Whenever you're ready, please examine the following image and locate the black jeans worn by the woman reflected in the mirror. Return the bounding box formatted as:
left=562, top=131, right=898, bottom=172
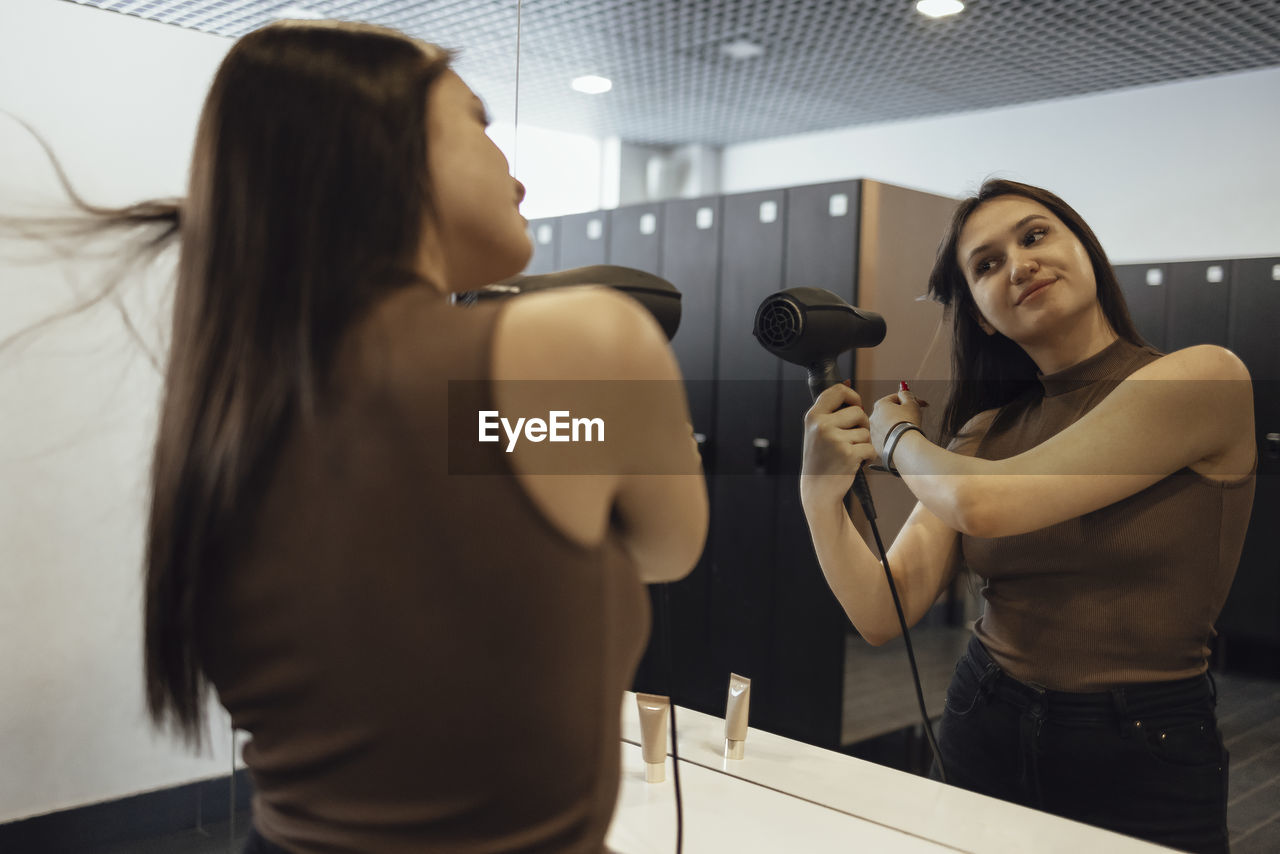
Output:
left=931, top=638, right=1228, bottom=854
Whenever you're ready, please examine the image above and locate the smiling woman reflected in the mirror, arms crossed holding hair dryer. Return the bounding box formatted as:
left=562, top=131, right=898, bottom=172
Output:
left=801, top=181, right=1256, bottom=851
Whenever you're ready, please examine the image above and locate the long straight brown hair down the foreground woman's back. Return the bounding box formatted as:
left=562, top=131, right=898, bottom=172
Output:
left=136, top=22, right=449, bottom=743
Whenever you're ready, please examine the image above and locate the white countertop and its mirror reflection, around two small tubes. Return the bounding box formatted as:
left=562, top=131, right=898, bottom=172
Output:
left=609, top=696, right=1171, bottom=854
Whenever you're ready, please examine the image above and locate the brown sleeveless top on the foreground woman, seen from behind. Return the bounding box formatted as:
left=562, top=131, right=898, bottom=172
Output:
left=206, top=288, right=649, bottom=854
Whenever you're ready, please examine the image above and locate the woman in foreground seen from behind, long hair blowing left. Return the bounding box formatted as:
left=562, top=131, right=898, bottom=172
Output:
left=42, top=15, right=707, bottom=854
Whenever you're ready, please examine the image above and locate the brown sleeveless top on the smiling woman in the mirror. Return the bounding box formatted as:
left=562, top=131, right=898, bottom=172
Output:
left=952, top=339, right=1254, bottom=691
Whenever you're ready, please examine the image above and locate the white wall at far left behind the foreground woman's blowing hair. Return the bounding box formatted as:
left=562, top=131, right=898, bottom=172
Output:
left=0, top=0, right=240, bottom=821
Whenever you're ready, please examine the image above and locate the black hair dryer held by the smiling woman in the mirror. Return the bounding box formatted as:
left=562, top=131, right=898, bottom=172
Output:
left=751, top=288, right=886, bottom=519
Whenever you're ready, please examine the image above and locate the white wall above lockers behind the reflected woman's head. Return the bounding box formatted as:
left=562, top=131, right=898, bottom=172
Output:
left=721, top=68, right=1280, bottom=262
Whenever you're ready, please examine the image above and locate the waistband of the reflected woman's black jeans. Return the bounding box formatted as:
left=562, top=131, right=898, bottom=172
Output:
left=968, top=638, right=1217, bottom=718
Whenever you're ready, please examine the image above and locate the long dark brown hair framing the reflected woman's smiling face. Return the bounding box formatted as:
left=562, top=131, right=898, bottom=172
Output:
left=929, top=179, right=1147, bottom=444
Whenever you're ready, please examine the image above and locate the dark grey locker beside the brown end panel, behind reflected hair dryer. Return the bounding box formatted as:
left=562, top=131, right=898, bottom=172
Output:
left=772, top=181, right=861, bottom=749
